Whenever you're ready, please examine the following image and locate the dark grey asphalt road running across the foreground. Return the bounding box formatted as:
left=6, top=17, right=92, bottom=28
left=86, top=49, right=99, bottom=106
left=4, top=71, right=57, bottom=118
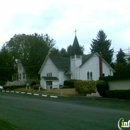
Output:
left=0, top=92, right=130, bottom=130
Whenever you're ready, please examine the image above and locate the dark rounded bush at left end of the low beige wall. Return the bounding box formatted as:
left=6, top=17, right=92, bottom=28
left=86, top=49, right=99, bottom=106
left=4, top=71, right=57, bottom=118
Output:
left=96, top=80, right=109, bottom=97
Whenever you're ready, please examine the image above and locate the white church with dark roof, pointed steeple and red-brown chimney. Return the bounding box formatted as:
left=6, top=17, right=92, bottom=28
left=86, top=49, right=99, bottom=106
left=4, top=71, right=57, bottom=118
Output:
left=39, top=36, right=114, bottom=89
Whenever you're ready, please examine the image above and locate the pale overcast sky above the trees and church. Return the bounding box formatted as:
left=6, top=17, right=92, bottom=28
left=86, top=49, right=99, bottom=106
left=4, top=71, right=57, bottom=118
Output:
left=0, top=0, right=130, bottom=57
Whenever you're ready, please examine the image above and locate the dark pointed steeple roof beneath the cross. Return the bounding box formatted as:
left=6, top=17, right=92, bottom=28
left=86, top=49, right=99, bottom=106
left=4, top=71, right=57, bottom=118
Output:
left=71, top=36, right=82, bottom=56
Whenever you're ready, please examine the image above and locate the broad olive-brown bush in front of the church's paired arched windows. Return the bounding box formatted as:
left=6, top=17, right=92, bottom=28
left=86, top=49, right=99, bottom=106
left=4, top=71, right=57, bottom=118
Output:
left=74, top=80, right=96, bottom=96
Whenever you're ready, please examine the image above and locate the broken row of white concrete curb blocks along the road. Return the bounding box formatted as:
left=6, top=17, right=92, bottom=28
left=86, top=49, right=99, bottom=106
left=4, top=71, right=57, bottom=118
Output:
left=1, top=90, right=58, bottom=98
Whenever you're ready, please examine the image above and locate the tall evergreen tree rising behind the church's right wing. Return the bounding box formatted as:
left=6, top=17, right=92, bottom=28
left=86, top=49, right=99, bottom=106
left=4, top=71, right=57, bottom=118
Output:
left=90, top=30, right=114, bottom=63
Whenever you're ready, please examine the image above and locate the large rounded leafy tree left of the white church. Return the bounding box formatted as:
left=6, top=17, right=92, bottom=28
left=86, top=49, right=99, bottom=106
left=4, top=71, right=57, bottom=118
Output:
left=6, top=33, right=55, bottom=78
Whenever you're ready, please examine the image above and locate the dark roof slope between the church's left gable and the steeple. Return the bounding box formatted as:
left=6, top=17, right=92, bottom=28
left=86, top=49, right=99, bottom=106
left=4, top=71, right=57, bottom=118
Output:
left=49, top=56, right=70, bottom=70
